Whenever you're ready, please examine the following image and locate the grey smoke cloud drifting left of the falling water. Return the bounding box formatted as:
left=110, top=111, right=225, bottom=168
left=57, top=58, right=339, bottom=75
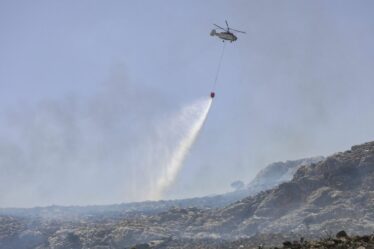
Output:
left=0, top=71, right=175, bottom=206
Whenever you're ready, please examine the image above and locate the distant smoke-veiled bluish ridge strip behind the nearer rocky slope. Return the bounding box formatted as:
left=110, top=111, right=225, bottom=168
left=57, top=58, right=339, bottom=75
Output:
left=0, top=157, right=323, bottom=220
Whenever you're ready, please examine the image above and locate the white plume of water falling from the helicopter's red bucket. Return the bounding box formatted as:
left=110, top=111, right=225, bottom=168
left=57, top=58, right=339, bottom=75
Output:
left=151, top=98, right=212, bottom=199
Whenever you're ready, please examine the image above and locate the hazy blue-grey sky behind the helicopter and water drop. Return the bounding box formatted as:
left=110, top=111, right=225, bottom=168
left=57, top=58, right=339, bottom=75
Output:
left=0, top=0, right=374, bottom=207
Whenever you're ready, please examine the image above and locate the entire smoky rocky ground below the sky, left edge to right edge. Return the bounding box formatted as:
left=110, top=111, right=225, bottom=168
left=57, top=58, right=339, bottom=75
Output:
left=0, top=142, right=374, bottom=249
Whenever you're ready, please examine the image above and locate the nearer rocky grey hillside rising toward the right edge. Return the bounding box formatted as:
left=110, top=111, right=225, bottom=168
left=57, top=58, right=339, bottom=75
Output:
left=115, top=142, right=374, bottom=246
